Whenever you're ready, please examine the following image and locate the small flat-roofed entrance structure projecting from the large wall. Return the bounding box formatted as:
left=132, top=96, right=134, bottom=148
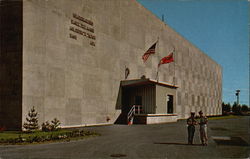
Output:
left=121, top=78, right=178, bottom=124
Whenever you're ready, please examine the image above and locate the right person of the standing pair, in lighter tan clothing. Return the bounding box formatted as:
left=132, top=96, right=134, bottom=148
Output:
left=199, top=111, right=208, bottom=146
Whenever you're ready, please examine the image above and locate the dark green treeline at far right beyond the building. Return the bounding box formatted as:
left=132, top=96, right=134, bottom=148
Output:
left=222, top=102, right=250, bottom=115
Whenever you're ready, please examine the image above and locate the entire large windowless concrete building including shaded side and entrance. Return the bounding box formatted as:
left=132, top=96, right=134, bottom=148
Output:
left=0, top=0, right=222, bottom=129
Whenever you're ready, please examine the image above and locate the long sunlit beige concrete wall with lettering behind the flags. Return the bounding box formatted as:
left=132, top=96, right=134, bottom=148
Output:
left=22, top=0, right=221, bottom=126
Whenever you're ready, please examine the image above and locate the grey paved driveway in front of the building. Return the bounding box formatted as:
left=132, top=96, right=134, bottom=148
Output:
left=0, top=117, right=250, bottom=159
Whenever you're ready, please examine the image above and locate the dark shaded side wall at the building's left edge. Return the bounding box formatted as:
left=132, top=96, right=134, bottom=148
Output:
left=0, top=0, right=22, bottom=130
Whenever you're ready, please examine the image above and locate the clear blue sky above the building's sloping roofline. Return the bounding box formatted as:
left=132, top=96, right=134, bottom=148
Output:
left=137, top=0, right=250, bottom=105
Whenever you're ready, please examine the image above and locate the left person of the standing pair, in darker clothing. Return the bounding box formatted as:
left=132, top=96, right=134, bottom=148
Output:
left=187, top=112, right=197, bottom=145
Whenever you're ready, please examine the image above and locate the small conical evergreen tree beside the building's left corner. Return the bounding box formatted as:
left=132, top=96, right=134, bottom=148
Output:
left=23, top=106, right=39, bottom=132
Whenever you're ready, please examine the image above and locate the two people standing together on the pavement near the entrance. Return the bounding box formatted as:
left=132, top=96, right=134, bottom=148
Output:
left=187, top=111, right=208, bottom=146
